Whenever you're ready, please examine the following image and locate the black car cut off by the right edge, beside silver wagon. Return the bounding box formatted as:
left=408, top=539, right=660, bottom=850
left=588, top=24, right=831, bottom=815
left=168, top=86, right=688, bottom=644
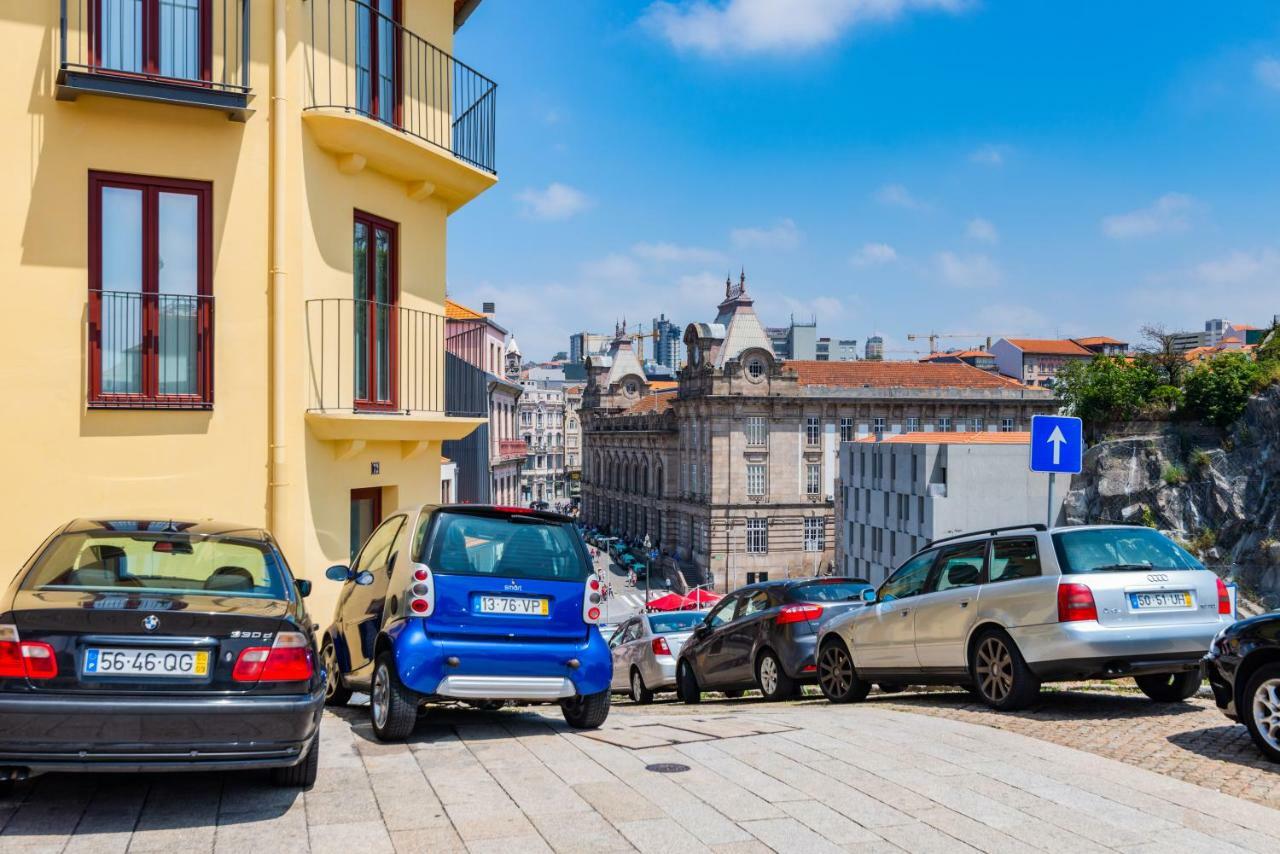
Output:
left=1204, top=612, right=1280, bottom=762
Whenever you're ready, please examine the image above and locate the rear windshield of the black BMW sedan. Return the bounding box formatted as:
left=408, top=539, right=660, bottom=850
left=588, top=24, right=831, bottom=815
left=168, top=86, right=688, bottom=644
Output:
left=22, top=531, right=287, bottom=599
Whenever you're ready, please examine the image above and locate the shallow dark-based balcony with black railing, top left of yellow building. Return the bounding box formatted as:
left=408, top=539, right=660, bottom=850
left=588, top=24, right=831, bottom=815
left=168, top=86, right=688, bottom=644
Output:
left=56, top=0, right=252, bottom=122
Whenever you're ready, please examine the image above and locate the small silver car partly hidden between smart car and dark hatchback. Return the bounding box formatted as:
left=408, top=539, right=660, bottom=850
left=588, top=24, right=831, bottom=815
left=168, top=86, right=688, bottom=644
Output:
left=609, top=611, right=707, bottom=703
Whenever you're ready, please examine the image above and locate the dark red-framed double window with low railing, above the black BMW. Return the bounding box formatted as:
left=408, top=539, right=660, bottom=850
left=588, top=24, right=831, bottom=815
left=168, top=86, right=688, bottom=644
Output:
left=88, top=172, right=214, bottom=408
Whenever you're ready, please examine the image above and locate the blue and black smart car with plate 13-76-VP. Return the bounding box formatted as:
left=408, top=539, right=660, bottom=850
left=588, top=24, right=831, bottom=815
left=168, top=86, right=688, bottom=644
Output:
left=321, top=504, right=613, bottom=740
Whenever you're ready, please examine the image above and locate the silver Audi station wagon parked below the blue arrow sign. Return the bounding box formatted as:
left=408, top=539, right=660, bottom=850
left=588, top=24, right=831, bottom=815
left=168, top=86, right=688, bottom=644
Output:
left=818, top=525, right=1233, bottom=709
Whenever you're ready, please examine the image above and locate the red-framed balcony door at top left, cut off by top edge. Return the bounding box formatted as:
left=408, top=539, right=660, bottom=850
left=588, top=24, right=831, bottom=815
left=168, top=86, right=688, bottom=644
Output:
left=88, top=0, right=212, bottom=81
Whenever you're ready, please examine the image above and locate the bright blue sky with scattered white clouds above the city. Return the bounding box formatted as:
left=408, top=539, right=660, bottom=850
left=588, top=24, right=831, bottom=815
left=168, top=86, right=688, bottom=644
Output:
left=448, top=0, right=1280, bottom=359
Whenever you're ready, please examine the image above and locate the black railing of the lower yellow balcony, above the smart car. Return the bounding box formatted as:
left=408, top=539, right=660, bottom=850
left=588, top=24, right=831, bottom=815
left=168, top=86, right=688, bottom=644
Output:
left=306, top=297, right=444, bottom=415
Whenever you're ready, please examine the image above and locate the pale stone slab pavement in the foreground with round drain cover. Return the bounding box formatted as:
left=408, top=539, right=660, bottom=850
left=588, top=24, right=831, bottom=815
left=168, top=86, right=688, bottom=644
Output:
left=0, top=698, right=1280, bottom=854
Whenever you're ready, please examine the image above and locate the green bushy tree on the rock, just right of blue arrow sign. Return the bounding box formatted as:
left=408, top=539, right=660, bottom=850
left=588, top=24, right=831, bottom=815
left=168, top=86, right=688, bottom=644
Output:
left=1053, top=356, right=1161, bottom=429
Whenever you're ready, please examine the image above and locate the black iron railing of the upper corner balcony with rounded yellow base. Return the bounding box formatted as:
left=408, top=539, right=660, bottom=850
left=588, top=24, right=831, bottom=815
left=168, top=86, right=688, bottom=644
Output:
left=305, top=0, right=498, bottom=173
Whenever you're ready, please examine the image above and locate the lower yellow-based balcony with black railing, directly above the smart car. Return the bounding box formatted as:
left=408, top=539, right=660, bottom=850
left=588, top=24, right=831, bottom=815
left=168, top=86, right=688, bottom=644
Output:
left=305, top=297, right=488, bottom=458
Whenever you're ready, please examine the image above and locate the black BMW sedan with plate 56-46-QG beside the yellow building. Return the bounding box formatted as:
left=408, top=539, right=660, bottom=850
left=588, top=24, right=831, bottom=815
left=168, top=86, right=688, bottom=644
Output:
left=0, top=520, right=324, bottom=786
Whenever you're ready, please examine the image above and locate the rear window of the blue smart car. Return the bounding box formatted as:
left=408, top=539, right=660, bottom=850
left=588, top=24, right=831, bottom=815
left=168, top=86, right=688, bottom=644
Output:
left=415, top=510, right=591, bottom=581
